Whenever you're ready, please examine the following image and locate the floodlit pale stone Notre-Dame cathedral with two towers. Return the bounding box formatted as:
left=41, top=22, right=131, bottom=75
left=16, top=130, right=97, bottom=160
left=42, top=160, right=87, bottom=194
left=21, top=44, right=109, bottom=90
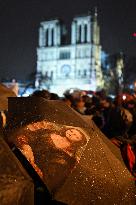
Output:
left=37, top=12, right=103, bottom=95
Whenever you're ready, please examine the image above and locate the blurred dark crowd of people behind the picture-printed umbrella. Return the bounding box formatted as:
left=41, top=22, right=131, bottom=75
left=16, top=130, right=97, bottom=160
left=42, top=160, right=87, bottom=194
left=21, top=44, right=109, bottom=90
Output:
left=31, top=90, right=136, bottom=176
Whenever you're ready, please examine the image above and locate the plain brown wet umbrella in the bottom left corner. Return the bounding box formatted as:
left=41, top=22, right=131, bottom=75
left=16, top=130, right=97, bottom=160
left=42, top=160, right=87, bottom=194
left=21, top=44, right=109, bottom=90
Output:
left=0, top=136, right=34, bottom=205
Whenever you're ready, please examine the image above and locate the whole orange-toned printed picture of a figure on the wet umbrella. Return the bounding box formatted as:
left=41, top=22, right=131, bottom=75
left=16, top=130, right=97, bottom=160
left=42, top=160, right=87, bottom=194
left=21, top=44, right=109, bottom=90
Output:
left=14, top=121, right=88, bottom=191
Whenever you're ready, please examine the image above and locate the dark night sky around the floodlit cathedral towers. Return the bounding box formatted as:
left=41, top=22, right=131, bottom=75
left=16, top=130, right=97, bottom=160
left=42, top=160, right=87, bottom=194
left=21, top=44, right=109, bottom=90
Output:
left=0, top=0, right=136, bottom=80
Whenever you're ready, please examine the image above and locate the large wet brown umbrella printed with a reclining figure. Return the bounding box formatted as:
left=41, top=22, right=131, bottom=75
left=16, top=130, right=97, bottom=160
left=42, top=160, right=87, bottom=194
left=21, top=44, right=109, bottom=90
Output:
left=8, top=97, right=136, bottom=205
